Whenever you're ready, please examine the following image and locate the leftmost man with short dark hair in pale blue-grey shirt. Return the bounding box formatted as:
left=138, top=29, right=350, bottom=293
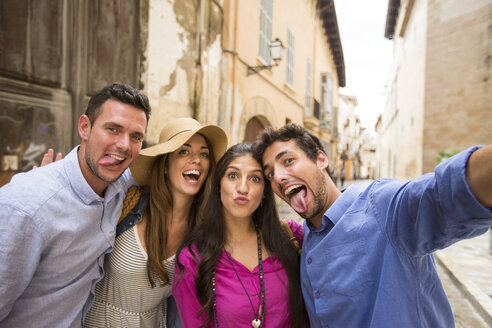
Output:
left=0, top=84, right=150, bottom=327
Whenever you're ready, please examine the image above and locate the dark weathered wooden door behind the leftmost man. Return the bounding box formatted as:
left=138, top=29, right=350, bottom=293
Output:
left=0, top=0, right=146, bottom=185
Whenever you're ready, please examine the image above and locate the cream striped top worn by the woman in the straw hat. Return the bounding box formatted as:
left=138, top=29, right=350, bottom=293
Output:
left=84, top=226, right=175, bottom=328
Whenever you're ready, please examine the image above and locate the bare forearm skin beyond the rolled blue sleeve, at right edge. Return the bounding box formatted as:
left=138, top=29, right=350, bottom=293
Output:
left=466, top=145, right=492, bottom=207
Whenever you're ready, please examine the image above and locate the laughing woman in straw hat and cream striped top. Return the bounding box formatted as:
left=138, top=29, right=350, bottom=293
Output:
left=84, top=118, right=227, bottom=327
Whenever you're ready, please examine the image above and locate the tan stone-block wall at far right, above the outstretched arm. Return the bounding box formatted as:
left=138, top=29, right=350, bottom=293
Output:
left=423, top=0, right=492, bottom=172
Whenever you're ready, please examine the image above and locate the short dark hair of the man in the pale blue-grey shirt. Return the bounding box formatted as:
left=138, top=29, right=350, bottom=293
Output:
left=85, top=83, right=151, bottom=125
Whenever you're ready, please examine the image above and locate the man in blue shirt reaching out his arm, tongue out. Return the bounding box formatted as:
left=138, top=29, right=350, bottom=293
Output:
left=255, top=124, right=492, bottom=328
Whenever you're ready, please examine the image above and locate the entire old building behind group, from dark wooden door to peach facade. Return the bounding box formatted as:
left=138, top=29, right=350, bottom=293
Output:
left=0, top=0, right=345, bottom=185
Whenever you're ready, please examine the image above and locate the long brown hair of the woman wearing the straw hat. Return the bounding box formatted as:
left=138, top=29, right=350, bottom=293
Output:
left=145, top=137, right=215, bottom=287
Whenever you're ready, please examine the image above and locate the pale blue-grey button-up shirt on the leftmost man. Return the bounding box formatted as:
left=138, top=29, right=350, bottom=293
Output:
left=0, top=147, right=134, bottom=327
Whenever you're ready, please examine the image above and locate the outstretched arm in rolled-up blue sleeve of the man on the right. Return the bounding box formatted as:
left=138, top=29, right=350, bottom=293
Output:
left=370, top=145, right=492, bottom=256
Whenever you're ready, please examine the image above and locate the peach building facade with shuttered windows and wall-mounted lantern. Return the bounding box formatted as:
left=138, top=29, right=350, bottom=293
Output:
left=219, top=0, right=345, bottom=159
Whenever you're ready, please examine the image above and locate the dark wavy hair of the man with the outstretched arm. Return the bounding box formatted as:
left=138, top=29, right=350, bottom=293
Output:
left=253, top=123, right=331, bottom=178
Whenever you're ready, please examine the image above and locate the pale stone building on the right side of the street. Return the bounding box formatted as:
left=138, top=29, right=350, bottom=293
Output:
left=378, top=0, right=492, bottom=179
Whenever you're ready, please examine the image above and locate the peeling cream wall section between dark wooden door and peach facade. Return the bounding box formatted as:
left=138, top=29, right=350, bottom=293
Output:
left=141, top=0, right=222, bottom=144
